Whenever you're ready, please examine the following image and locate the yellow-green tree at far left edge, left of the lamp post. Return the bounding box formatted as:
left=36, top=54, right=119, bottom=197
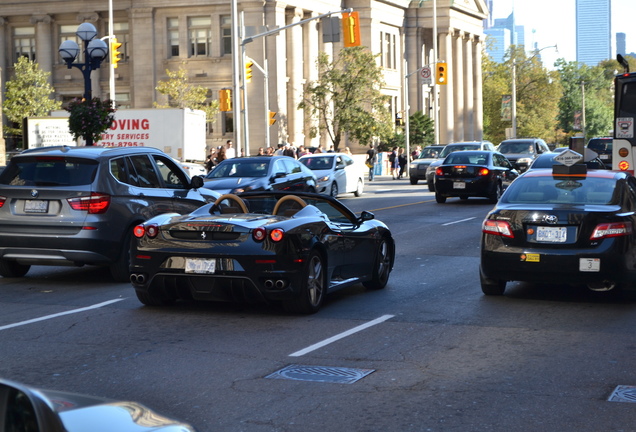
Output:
left=3, top=57, right=62, bottom=136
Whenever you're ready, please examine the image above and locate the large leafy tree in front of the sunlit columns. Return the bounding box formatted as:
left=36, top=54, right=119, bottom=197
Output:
left=298, top=47, right=393, bottom=151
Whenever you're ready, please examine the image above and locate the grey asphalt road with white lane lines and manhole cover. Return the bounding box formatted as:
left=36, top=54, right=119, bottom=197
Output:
left=0, top=177, right=636, bottom=432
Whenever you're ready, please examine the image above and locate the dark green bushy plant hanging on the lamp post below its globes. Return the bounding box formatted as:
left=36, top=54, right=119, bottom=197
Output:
left=66, top=98, right=115, bottom=143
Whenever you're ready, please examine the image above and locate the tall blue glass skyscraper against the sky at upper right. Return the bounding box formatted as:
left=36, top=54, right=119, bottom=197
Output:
left=576, top=0, right=612, bottom=66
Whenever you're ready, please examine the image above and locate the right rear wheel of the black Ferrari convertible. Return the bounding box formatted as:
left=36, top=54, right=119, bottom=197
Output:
left=283, top=250, right=327, bottom=314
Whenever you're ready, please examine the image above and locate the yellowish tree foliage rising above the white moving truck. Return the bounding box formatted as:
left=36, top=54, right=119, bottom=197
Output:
left=155, top=65, right=219, bottom=123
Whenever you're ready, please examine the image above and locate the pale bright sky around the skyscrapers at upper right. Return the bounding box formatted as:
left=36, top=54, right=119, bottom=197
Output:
left=491, top=0, right=636, bottom=69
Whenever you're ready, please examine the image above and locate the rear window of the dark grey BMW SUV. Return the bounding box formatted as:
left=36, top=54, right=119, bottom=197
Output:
left=0, top=156, right=98, bottom=186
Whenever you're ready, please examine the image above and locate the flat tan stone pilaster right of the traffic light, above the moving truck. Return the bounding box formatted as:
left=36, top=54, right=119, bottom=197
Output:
left=128, top=8, right=154, bottom=107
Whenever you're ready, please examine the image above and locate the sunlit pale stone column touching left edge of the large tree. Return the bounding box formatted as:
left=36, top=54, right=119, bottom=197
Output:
left=287, top=8, right=305, bottom=145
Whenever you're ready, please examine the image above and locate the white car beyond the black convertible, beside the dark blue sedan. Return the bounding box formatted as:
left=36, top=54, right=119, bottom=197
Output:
left=298, top=153, right=364, bottom=197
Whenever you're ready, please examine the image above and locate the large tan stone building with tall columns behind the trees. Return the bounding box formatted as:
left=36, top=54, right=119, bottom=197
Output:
left=0, top=0, right=488, bottom=157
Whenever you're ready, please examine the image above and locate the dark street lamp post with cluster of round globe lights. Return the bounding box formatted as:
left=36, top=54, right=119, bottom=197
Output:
left=58, top=23, right=108, bottom=146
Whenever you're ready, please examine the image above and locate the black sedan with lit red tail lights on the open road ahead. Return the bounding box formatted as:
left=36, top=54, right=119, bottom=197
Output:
left=435, top=151, right=519, bottom=203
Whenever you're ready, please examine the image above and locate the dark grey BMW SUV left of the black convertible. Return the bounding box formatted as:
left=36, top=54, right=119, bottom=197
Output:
left=0, top=146, right=219, bottom=282
